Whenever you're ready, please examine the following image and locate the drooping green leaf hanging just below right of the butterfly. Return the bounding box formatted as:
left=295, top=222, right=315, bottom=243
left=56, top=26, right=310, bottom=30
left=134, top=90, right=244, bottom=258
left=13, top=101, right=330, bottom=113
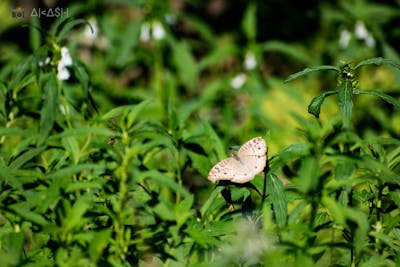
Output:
left=267, top=172, right=288, bottom=227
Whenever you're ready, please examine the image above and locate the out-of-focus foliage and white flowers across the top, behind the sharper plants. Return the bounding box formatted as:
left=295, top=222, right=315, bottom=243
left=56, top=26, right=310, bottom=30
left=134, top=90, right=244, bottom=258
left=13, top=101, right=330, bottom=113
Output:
left=0, top=0, right=400, bottom=153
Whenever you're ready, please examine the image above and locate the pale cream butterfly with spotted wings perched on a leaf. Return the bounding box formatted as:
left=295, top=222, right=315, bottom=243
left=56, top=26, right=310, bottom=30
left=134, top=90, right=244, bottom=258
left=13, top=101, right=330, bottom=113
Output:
left=208, top=136, right=267, bottom=184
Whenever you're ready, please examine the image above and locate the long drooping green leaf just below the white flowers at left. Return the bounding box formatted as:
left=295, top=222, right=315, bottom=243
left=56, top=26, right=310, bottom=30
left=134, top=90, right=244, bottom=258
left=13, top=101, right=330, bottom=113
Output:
left=38, top=75, right=58, bottom=144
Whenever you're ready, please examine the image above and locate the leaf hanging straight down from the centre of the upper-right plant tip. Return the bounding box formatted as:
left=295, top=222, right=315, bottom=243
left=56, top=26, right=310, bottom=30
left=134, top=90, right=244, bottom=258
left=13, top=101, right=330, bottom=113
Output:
left=338, top=79, right=353, bottom=129
